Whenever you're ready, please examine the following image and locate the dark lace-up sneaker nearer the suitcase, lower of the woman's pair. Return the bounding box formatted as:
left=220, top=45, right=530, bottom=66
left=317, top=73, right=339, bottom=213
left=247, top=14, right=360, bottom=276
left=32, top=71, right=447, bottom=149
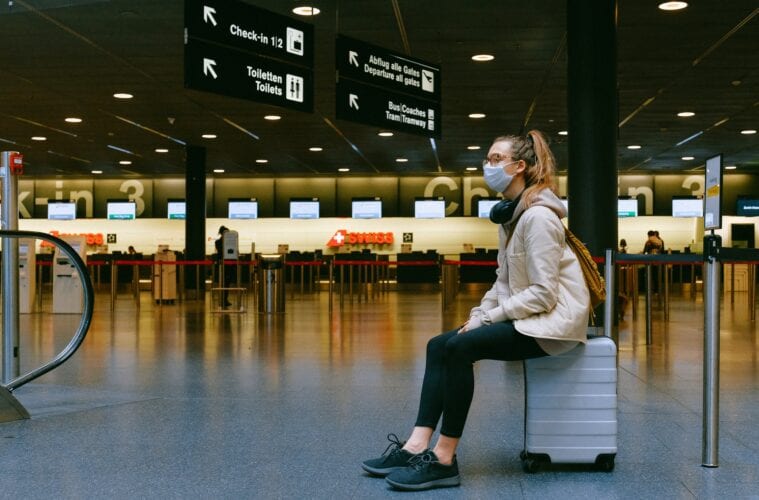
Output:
left=385, top=450, right=461, bottom=491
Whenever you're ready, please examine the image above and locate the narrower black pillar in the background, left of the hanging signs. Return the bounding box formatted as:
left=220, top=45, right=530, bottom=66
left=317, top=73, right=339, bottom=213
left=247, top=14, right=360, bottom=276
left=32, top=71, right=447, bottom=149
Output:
left=184, top=146, right=206, bottom=298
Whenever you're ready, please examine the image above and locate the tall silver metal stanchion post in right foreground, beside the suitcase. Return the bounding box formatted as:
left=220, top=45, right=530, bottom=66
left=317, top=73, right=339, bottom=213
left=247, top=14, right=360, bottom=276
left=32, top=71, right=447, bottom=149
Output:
left=701, top=234, right=722, bottom=467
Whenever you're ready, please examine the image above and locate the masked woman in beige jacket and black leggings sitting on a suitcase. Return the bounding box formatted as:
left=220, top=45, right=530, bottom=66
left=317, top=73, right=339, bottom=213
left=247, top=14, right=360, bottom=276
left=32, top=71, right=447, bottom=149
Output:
left=362, top=130, right=590, bottom=490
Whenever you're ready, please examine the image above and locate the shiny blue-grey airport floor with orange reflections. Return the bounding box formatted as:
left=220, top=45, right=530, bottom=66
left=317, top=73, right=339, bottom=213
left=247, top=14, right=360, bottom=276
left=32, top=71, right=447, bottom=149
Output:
left=0, top=284, right=759, bottom=499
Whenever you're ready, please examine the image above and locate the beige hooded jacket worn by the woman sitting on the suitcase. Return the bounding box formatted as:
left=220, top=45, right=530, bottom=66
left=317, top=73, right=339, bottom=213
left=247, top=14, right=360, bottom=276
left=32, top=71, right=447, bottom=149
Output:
left=471, top=189, right=590, bottom=355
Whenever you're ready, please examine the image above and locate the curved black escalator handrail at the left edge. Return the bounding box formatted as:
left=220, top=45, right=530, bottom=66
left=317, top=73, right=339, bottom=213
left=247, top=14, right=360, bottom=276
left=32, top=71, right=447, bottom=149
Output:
left=0, top=230, right=95, bottom=392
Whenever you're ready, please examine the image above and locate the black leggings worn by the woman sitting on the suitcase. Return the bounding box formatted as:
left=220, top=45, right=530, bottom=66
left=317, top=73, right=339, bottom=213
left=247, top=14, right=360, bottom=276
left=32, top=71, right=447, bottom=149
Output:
left=416, top=321, right=547, bottom=438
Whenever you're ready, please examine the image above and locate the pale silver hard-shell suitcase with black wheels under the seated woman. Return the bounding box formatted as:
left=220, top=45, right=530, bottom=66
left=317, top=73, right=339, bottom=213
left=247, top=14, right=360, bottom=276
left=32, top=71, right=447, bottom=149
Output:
left=521, top=337, right=617, bottom=472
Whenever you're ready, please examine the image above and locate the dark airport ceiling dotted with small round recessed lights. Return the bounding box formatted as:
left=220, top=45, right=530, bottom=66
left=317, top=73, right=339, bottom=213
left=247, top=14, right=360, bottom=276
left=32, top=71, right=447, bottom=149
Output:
left=0, top=0, right=759, bottom=177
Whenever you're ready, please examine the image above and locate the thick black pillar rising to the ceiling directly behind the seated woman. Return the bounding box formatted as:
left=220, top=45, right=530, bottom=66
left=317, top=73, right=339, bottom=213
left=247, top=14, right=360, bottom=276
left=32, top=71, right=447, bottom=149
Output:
left=567, top=0, right=618, bottom=304
